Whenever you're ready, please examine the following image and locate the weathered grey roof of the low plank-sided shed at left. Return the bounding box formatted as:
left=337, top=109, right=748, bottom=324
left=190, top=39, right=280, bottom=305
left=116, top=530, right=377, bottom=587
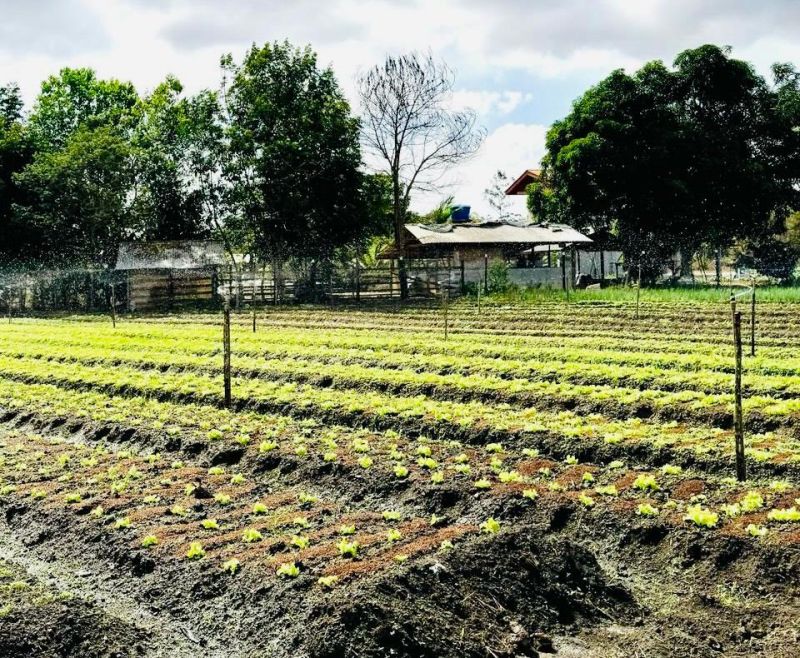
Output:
left=116, top=240, right=225, bottom=270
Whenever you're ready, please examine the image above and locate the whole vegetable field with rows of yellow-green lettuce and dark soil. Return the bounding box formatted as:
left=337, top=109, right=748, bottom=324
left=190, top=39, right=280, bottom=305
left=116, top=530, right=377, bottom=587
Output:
left=0, top=300, right=800, bottom=658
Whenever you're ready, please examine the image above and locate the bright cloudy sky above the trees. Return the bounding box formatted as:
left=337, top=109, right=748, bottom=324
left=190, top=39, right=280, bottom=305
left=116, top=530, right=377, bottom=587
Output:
left=0, top=0, right=800, bottom=214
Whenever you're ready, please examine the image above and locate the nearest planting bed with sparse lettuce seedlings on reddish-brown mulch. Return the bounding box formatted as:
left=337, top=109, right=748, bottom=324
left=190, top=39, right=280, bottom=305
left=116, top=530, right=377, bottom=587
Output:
left=0, top=420, right=800, bottom=587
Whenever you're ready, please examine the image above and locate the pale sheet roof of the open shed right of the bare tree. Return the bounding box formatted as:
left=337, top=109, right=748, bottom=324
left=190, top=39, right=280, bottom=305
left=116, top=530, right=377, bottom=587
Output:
left=406, top=223, right=591, bottom=245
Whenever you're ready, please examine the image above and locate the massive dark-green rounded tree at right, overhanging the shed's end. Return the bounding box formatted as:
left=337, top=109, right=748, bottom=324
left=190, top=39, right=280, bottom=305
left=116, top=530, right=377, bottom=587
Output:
left=529, top=45, right=796, bottom=278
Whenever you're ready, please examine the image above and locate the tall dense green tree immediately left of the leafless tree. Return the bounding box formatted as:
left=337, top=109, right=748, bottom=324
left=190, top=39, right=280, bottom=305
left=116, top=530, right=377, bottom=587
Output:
left=222, top=42, right=365, bottom=258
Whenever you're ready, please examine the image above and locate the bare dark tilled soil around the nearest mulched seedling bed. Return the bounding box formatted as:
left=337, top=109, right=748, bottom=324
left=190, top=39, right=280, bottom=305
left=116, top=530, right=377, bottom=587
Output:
left=0, top=408, right=800, bottom=658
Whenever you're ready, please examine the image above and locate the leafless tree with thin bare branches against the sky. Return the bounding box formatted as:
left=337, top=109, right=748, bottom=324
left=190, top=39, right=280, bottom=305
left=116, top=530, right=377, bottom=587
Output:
left=358, top=53, right=484, bottom=299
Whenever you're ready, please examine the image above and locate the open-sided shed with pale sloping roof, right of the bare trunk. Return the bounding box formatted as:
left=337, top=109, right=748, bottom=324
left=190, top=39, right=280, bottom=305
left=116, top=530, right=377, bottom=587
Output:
left=381, top=221, right=591, bottom=287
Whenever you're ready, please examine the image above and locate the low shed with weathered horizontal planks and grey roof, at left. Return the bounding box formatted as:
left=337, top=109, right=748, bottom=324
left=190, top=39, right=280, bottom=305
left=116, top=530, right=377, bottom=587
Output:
left=115, top=240, right=225, bottom=311
